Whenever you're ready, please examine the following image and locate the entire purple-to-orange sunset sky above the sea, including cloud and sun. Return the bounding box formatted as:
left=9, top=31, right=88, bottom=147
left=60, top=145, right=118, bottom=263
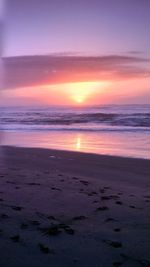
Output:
left=0, top=0, right=150, bottom=105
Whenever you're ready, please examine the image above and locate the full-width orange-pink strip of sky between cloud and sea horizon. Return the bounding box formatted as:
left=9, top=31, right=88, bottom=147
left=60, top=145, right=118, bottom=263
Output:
left=0, top=78, right=150, bottom=106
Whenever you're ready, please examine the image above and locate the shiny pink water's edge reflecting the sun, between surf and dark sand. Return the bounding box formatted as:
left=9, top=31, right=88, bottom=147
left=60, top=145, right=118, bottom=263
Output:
left=0, top=131, right=150, bottom=159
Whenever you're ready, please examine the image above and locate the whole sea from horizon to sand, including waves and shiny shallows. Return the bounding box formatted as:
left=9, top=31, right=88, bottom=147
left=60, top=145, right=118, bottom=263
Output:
left=0, top=105, right=150, bottom=159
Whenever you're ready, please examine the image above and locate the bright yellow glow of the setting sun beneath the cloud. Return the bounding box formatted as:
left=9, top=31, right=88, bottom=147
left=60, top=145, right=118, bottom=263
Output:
left=36, top=81, right=110, bottom=106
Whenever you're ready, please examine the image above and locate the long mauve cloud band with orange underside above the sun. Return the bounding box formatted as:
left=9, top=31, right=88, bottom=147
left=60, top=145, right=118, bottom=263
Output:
left=3, top=54, right=150, bottom=89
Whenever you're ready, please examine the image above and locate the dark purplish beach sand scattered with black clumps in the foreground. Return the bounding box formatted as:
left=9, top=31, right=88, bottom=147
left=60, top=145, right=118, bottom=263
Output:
left=0, top=147, right=150, bottom=267
